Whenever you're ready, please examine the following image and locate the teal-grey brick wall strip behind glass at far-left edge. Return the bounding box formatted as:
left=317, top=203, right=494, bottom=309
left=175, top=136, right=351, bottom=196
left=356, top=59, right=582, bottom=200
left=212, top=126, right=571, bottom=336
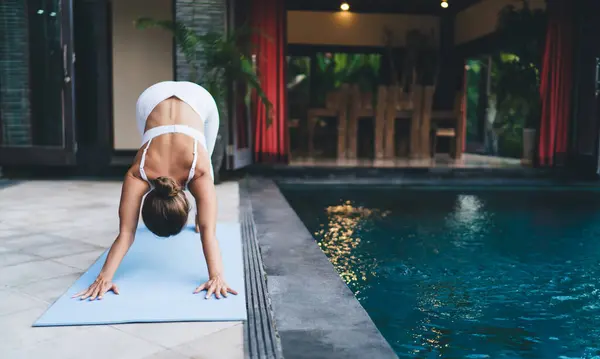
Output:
left=0, top=0, right=31, bottom=146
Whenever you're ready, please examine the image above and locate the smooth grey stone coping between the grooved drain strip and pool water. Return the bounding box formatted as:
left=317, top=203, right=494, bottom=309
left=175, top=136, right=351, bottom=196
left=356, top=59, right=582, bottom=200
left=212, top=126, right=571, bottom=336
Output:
left=240, top=177, right=397, bottom=359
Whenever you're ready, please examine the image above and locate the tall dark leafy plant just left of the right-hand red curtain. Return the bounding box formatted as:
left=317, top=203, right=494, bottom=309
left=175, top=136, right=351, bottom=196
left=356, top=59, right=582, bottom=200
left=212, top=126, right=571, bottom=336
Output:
left=495, top=0, right=546, bottom=163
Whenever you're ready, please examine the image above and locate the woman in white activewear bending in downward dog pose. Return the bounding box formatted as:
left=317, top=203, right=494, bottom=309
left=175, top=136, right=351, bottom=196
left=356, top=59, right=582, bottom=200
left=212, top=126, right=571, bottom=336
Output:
left=73, top=81, right=237, bottom=300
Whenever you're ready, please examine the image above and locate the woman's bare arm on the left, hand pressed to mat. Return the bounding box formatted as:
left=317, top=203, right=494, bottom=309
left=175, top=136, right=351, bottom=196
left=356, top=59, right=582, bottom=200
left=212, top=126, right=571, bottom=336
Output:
left=74, top=171, right=148, bottom=300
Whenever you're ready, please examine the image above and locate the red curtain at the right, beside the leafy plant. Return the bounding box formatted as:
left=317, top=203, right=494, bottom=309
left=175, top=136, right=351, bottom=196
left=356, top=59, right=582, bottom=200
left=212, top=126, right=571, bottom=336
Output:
left=538, top=0, right=574, bottom=166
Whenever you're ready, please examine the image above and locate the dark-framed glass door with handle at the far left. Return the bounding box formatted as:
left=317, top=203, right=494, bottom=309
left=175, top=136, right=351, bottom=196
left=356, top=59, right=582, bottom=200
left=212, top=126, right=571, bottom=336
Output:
left=0, top=0, right=76, bottom=165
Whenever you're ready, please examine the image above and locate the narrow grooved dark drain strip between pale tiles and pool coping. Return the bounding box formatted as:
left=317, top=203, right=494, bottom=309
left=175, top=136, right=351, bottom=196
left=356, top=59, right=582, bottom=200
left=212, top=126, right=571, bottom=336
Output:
left=239, top=181, right=283, bottom=359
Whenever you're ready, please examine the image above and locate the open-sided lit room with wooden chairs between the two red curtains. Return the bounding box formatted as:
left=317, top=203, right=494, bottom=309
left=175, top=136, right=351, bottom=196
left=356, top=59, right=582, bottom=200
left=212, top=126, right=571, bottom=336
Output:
left=286, top=0, right=545, bottom=168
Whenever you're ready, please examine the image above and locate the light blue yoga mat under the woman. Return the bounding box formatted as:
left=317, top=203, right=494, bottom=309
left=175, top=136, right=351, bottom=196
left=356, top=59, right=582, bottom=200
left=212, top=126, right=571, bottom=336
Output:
left=33, top=223, right=246, bottom=327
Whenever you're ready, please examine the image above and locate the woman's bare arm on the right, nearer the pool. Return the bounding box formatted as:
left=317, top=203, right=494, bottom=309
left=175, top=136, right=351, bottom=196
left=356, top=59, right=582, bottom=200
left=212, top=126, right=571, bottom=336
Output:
left=189, top=173, right=237, bottom=299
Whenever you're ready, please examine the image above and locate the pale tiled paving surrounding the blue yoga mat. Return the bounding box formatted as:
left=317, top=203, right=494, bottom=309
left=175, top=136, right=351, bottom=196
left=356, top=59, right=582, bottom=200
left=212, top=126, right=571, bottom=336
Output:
left=0, top=181, right=244, bottom=359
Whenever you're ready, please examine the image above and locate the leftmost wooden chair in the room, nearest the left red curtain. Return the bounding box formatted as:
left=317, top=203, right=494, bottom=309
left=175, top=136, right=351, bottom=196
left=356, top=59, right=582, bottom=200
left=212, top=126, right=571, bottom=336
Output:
left=307, top=85, right=349, bottom=159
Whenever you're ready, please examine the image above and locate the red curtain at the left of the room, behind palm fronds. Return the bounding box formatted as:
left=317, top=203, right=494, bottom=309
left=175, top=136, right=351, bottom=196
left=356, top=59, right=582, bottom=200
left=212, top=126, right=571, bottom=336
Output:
left=251, top=0, right=289, bottom=163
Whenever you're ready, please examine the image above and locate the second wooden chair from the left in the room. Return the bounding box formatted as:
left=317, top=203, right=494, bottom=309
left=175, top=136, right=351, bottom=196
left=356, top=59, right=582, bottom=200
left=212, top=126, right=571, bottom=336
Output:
left=347, top=85, right=387, bottom=159
